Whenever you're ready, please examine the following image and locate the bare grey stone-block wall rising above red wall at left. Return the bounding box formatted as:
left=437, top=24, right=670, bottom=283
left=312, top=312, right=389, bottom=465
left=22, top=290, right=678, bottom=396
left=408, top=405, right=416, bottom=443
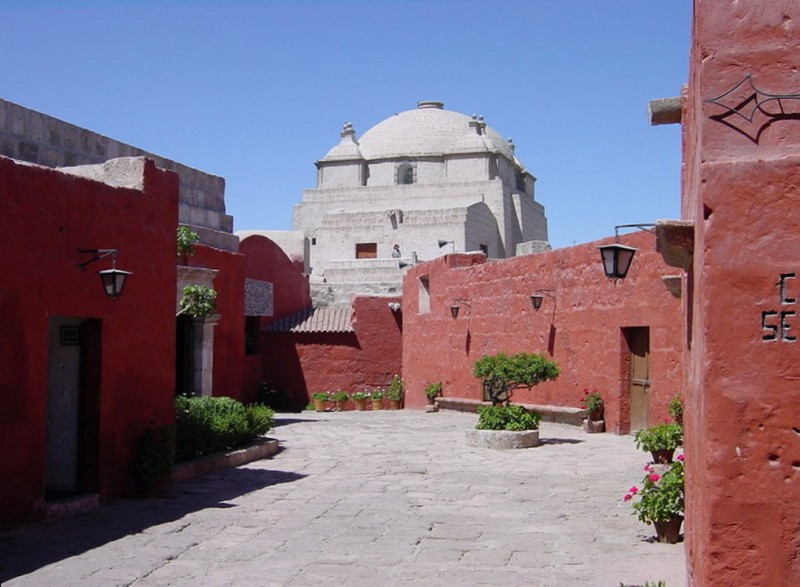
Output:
left=0, top=99, right=238, bottom=251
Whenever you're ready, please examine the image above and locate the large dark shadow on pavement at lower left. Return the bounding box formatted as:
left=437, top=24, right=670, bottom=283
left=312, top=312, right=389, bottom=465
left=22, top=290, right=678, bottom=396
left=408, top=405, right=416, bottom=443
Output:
left=0, top=468, right=305, bottom=584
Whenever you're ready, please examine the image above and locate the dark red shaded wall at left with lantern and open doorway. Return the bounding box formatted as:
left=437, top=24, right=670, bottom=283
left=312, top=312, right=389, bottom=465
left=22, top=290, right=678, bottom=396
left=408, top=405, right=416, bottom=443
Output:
left=0, top=157, right=178, bottom=527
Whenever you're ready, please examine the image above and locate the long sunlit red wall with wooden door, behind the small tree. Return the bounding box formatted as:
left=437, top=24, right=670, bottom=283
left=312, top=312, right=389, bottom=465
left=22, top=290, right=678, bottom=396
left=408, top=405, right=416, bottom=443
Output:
left=403, top=232, right=683, bottom=432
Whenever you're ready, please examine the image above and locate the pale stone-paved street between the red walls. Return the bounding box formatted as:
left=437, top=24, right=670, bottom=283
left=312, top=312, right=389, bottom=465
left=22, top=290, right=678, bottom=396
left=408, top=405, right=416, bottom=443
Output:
left=0, top=410, right=684, bottom=587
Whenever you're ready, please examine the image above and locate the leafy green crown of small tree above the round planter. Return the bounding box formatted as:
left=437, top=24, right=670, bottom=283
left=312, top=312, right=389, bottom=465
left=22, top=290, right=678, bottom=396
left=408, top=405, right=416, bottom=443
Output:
left=472, top=353, right=560, bottom=406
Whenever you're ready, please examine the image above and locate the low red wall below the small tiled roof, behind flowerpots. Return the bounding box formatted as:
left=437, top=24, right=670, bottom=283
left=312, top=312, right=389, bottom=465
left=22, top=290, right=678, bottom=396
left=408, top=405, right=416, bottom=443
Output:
left=263, top=296, right=403, bottom=408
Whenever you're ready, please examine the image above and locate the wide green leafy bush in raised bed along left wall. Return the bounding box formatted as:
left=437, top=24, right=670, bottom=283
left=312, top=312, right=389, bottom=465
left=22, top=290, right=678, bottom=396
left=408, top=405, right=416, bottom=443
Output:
left=175, top=396, right=275, bottom=461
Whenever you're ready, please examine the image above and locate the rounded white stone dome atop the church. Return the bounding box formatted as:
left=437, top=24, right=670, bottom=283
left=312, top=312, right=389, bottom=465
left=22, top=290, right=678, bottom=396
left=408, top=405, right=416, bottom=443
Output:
left=358, top=102, right=514, bottom=160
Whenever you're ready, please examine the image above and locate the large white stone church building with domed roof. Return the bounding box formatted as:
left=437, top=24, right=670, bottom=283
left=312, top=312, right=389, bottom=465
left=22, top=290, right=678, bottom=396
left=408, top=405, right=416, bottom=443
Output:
left=294, top=102, right=547, bottom=305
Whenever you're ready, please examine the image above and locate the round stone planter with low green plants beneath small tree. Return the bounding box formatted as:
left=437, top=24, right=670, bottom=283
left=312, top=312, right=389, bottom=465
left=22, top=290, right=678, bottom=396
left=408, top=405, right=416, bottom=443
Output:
left=467, top=405, right=542, bottom=449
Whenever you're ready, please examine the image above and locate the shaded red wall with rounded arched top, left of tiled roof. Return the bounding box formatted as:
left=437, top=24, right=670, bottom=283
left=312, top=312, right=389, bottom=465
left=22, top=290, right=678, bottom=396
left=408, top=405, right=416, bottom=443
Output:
left=239, top=235, right=311, bottom=401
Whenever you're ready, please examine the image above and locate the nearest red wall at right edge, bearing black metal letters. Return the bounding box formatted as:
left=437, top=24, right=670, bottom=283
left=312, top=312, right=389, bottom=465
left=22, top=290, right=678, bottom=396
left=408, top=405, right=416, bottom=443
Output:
left=682, top=0, right=800, bottom=585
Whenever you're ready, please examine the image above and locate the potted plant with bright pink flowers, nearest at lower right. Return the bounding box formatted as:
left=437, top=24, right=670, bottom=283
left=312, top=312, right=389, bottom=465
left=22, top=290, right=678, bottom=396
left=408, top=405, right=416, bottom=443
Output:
left=622, top=455, right=684, bottom=544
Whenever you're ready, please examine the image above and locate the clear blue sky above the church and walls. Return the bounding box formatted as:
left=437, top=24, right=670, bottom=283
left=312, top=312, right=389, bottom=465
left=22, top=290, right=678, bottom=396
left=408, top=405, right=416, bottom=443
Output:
left=0, top=0, right=691, bottom=247
